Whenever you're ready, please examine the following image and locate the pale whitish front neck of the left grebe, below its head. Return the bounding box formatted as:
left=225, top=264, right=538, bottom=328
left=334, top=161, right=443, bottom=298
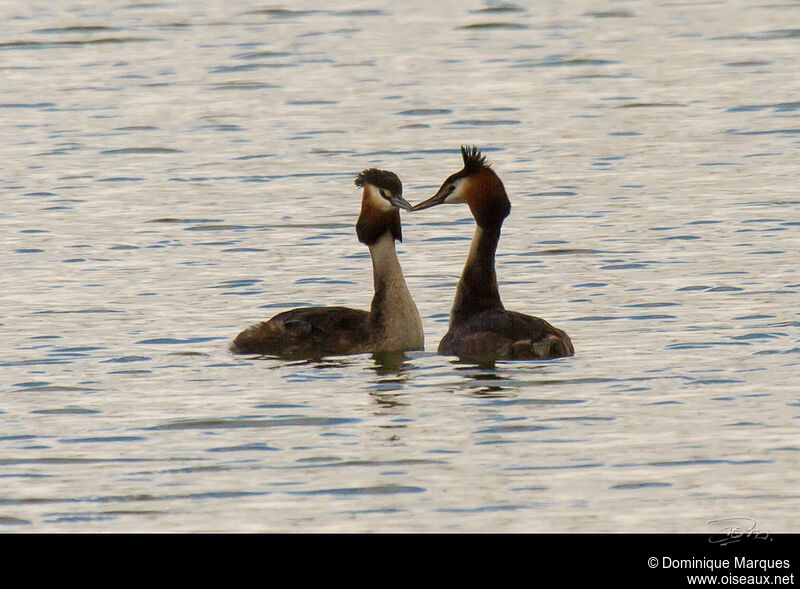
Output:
left=369, top=233, right=425, bottom=351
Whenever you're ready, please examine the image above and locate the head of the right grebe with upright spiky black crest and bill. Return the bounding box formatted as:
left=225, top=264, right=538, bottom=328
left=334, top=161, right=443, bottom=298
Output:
left=411, top=146, right=511, bottom=227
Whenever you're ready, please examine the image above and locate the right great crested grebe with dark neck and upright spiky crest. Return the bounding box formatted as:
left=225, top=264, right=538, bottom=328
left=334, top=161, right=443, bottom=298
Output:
left=411, top=147, right=575, bottom=360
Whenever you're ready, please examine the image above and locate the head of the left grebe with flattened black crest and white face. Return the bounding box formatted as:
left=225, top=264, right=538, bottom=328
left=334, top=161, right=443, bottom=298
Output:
left=355, top=168, right=411, bottom=245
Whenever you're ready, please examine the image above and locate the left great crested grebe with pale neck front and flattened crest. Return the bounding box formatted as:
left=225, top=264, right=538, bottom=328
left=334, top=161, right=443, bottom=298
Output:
left=230, top=168, right=425, bottom=358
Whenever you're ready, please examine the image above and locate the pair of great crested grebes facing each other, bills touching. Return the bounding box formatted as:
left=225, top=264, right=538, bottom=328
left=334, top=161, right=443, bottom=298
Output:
left=231, top=147, right=575, bottom=361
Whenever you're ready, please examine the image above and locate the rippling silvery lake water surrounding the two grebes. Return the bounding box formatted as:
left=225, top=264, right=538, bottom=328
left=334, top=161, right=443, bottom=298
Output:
left=0, top=0, right=800, bottom=532
